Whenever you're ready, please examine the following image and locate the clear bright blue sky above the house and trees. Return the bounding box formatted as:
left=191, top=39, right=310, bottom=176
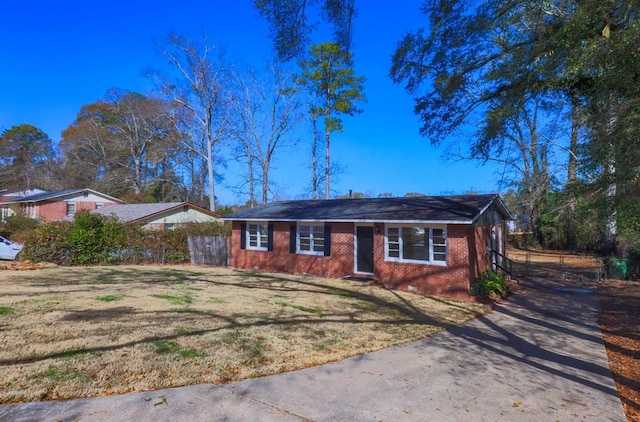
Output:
left=0, top=0, right=505, bottom=204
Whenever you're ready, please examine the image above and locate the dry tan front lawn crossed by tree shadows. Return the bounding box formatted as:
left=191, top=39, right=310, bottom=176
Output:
left=0, top=266, right=488, bottom=403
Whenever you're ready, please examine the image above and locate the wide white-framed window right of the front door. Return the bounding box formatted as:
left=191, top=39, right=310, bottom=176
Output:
left=384, top=225, right=447, bottom=265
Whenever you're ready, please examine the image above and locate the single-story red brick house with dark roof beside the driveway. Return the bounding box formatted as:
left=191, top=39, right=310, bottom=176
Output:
left=224, top=194, right=512, bottom=300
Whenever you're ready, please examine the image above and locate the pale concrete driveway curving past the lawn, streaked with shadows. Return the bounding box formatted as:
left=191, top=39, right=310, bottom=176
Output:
left=0, top=280, right=625, bottom=422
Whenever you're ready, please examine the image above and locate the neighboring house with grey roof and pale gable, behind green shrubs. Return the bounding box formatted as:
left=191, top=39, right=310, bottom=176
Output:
left=94, top=202, right=220, bottom=230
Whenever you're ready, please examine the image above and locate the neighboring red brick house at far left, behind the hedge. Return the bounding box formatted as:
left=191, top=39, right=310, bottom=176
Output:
left=0, top=189, right=123, bottom=221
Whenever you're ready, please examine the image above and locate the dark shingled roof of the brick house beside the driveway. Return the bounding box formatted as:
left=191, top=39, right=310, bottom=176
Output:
left=223, top=194, right=511, bottom=224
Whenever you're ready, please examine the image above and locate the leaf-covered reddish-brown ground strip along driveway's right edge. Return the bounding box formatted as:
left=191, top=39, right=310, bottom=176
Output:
left=597, top=280, right=640, bottom=422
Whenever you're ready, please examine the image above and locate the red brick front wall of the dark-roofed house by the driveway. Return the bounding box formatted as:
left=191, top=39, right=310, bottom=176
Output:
left=231, top=221, right=500, bottom=300
